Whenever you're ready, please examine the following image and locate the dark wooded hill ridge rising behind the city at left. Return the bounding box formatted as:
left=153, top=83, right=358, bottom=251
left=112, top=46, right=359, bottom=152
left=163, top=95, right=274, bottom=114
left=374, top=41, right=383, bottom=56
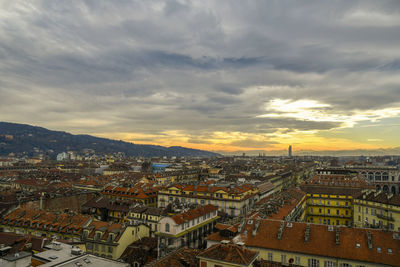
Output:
left=0, top=122, right=219, bottom=158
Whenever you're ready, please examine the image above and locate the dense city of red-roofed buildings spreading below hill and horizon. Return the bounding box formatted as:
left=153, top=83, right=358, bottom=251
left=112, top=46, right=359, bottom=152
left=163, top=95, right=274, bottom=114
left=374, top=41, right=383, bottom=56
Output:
left=0, top=148, right=400, bottom=267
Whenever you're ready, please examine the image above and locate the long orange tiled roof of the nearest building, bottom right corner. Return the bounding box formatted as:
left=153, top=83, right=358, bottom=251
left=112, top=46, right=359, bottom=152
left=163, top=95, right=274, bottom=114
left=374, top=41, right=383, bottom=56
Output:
left=207, top=219, right=400, bottom=266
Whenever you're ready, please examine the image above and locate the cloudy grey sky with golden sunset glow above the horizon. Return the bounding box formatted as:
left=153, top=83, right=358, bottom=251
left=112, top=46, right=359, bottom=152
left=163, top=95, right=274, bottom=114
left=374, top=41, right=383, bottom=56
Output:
left=0, top=0, right=400, bottom=153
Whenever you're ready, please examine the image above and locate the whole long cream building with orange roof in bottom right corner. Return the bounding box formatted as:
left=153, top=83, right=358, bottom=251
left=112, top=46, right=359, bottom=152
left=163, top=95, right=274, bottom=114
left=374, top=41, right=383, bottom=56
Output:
left=207, top=219, right=400, bottom=267
